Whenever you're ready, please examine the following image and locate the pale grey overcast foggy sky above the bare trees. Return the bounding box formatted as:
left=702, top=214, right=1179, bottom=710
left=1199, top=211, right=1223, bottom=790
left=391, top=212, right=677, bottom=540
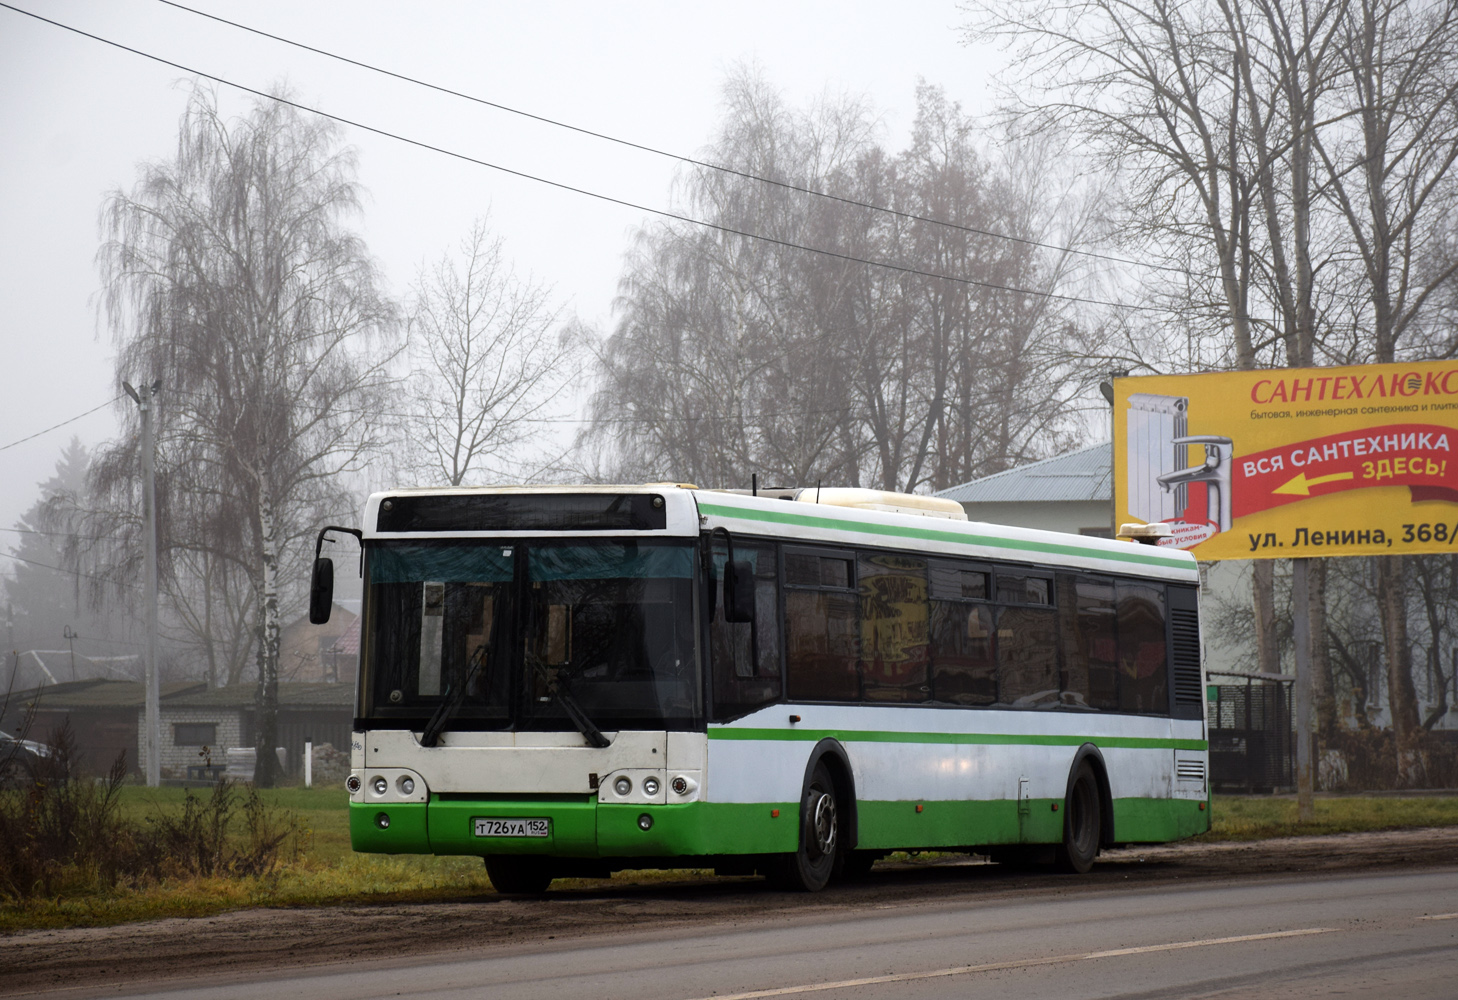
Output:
left=0, top=0, right=1000, bottom=571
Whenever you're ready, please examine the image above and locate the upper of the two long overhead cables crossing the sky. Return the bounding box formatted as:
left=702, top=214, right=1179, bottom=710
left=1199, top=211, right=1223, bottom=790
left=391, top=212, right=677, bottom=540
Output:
left=157, top=0, right=1198, bottom=277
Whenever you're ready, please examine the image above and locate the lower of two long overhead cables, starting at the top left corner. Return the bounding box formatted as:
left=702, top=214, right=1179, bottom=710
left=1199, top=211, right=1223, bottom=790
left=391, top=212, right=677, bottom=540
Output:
left=0, top=3, right=1162, bottom=312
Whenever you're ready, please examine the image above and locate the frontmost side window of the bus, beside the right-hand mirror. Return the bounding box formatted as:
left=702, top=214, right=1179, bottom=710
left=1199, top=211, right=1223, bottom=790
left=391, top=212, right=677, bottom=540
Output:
left=709, top=542, right=781, bottom=722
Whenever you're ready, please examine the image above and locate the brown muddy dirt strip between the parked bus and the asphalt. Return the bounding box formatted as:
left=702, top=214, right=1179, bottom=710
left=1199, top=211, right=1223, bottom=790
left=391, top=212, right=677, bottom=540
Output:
left=0, top=828, right=1458, bottom=996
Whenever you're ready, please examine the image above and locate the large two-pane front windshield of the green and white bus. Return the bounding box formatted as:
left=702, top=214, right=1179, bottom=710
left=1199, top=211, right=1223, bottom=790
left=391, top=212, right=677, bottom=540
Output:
left=363, top=539, right=703, bottom=730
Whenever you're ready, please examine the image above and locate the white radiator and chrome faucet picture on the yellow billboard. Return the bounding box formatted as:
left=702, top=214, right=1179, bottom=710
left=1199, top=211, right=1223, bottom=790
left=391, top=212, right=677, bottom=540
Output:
left=1124, top=392, right=1235, bottom=548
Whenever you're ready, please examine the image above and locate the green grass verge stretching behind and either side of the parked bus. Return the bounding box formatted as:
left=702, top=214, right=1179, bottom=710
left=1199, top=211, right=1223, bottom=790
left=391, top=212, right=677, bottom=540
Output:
left=8, top=786, right=1458, bottom=933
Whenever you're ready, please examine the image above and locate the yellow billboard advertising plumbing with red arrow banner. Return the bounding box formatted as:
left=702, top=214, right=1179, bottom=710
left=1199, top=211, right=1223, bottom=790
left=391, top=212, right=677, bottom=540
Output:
left=1114, top=362, right=1458, bottom=560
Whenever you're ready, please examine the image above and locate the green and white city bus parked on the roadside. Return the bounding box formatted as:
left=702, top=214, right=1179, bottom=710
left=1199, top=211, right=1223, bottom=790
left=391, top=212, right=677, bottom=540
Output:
left=311, top=484, right=1210, bottom=892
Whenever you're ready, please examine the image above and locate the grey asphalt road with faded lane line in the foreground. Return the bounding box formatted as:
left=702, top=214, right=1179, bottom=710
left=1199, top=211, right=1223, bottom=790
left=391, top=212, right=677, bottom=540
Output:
left=76, top=869, right=1458, bottom=1000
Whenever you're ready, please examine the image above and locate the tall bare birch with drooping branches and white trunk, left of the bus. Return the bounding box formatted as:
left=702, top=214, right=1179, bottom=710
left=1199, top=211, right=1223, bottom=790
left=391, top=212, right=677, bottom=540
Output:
left=93, top=87, right=394, bottom=787
